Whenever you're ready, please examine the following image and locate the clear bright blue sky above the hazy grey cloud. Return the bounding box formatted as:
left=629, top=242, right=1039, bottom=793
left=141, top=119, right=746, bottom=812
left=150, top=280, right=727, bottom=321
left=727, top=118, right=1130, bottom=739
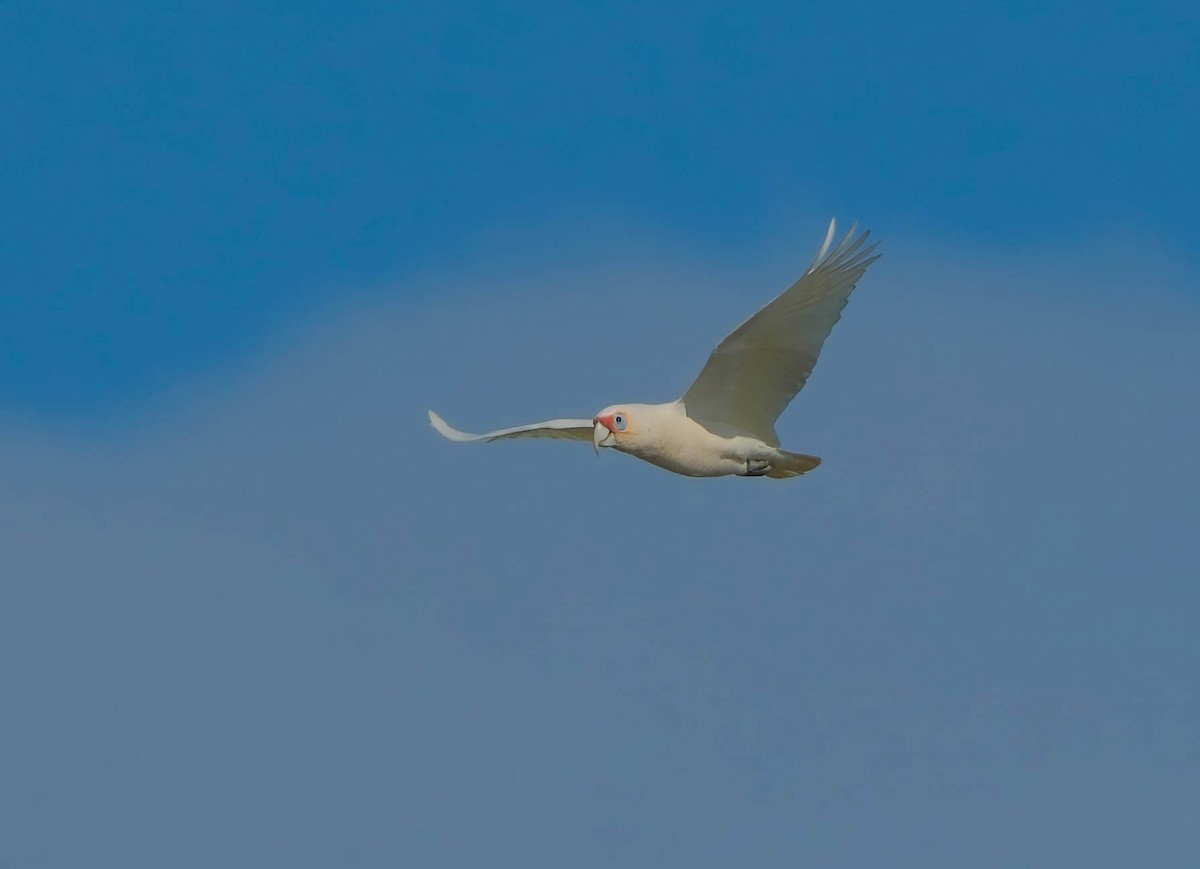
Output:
left=0, top=2, right=1200, bottom=419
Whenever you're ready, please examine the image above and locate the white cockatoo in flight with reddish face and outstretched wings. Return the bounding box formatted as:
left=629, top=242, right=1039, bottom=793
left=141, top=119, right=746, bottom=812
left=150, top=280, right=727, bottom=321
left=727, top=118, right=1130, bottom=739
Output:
left=428, top=220, right=881, bottom=479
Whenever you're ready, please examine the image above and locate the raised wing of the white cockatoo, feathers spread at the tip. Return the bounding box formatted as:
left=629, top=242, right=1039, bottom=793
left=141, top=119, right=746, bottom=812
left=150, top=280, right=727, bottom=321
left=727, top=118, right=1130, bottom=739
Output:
left=683, top=221, right=878, bottom=447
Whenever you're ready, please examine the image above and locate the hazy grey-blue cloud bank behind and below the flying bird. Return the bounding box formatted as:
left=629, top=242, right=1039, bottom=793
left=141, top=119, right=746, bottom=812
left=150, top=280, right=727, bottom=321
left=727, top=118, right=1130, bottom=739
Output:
left=0, top=234, right=1200, bottom=867
